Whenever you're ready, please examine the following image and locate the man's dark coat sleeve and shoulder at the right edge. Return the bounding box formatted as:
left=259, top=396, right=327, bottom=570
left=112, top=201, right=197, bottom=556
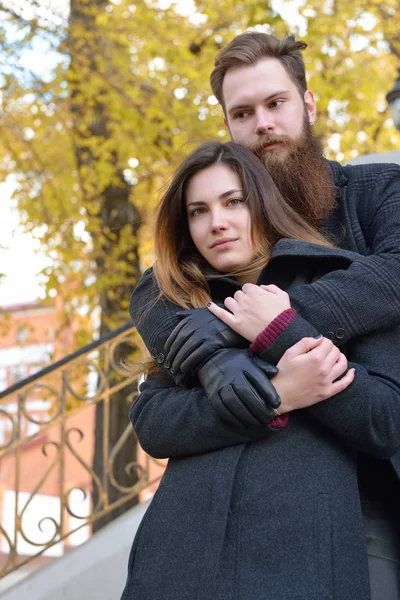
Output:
left=290, top=165, right=400, bottom=345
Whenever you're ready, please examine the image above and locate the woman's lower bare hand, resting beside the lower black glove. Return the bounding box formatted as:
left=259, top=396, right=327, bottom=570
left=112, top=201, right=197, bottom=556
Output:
left=272, top=337, right=355, bottom=412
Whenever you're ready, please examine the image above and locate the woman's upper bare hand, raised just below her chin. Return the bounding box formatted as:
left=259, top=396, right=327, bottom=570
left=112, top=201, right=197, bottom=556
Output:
left=208, top=283, right=290, bottom=342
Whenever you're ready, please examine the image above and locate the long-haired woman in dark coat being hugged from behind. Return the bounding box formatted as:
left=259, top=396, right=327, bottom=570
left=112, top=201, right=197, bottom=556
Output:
left=122, top=142, right=400, bottom=600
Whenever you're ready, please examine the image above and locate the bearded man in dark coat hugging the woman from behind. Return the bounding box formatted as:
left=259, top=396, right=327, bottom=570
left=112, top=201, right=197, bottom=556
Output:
left=130, top=32, right=400, bottom=600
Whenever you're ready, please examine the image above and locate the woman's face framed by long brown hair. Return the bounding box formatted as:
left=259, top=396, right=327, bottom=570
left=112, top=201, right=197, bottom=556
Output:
left=186, top=164, right=255, bottom=273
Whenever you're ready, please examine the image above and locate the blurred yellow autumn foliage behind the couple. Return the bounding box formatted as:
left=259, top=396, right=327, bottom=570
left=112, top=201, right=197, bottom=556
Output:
left=0, top=0, right=400, bottom=344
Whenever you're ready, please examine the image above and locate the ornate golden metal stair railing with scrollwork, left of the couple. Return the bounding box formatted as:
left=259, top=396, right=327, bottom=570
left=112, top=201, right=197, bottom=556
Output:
left=0, top=323, right=163, bottom=577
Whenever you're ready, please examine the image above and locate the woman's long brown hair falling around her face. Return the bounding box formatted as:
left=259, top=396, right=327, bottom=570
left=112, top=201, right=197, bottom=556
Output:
left=154, top=141, right=332, bottom=308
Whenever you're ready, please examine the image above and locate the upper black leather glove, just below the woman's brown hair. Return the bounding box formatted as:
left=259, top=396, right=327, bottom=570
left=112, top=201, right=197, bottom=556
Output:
left=164, top=308, right=249, bottom=375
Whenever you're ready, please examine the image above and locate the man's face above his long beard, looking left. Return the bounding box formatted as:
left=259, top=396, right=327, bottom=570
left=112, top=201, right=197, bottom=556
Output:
left=222, top=58, right=316, bottom=160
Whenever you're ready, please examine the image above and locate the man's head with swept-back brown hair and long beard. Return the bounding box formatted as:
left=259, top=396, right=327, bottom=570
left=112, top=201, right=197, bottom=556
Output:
left=210, top=33, right=334, bottom=226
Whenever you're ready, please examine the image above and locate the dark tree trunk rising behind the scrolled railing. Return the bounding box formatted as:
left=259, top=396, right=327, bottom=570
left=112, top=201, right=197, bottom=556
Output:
left=67, top=0, right=140, bottom=530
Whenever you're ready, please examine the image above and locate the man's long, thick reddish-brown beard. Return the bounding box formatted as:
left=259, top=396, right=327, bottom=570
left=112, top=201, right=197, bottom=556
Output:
left=250, top=116, right=336, bottom=228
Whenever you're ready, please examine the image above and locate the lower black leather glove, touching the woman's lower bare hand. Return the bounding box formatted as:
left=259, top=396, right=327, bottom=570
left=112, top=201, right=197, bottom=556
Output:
left=197, top=348, right=281, bottom=427
